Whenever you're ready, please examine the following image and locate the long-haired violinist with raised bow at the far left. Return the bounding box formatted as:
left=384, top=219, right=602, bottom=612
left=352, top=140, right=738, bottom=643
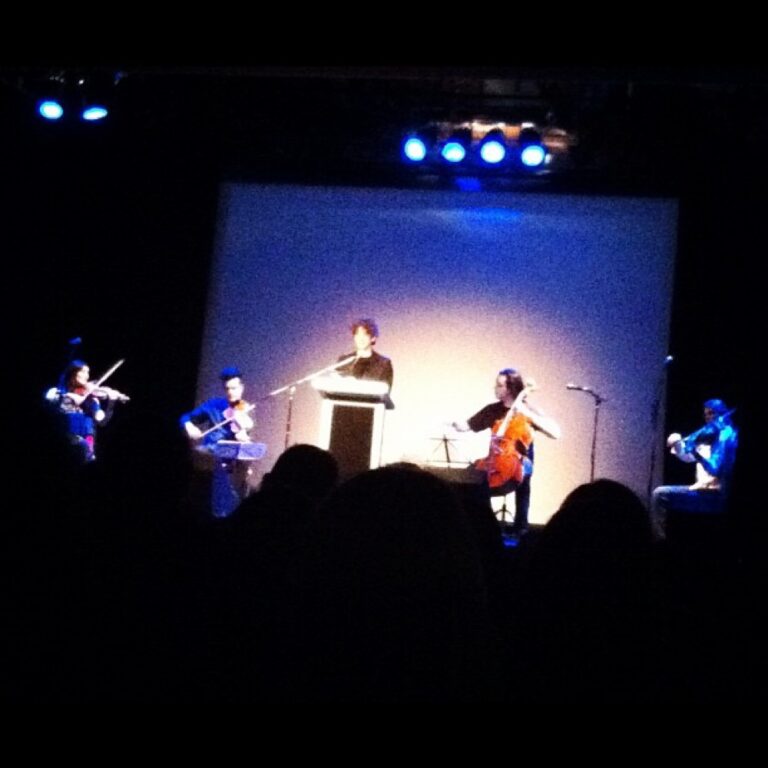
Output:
left=45, top=360, right=130, bottom=462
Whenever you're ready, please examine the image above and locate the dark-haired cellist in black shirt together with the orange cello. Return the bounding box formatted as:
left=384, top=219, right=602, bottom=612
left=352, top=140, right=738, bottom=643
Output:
left=453, top=368, right=560, bottom=534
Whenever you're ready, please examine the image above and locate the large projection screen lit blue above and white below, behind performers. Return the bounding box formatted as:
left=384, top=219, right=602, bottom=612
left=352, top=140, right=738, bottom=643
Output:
left=196, top=182, right=677, bottom=523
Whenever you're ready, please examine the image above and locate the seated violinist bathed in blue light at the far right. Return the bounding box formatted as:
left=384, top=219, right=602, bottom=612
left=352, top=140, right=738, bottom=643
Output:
left=651, top=398, right=739, bottom=539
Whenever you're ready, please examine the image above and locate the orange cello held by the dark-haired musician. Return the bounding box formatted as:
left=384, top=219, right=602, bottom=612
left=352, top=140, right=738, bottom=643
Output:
left=475, top=380, right=536, bottom=493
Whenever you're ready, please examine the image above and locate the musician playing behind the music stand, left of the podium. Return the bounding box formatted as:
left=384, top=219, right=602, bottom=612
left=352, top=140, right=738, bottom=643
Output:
left=179, top=367, right=254, bottom=517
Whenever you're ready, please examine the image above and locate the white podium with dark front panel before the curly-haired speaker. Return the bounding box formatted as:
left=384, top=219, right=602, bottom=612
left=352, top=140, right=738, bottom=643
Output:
left=312, top=376, right=394, bottom=479
